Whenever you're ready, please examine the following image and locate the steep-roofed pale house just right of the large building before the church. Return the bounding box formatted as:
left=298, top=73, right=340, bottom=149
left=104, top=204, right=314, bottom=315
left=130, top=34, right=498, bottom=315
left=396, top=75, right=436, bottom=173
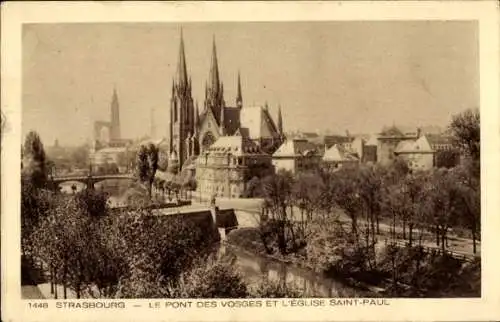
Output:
left=272, top=139, right=321, bottom=173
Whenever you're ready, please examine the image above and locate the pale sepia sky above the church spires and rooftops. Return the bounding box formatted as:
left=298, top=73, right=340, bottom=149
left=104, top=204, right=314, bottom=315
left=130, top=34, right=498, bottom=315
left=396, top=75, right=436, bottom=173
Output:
left=22, top=21, right=479, bottom=145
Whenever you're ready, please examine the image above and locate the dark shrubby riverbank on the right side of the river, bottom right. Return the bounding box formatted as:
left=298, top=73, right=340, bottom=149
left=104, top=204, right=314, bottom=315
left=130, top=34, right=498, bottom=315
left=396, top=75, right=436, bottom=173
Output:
left=227, top=228, right=481, bottom=298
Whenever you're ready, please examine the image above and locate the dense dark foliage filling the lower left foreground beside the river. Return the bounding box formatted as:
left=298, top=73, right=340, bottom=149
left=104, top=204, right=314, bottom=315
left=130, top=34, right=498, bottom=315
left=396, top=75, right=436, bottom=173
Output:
left=25, top=182, right=304, bottom=298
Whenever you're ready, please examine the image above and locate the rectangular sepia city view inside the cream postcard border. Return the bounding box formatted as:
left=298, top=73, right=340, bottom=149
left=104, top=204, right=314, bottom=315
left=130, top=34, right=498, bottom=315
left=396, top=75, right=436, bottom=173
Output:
left=20, top=21, right=481, bottom=299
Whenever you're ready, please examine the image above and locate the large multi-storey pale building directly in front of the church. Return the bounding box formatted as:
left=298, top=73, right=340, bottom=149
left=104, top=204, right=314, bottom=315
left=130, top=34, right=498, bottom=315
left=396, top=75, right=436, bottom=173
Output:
left=196, top=135, right=273, bottom=198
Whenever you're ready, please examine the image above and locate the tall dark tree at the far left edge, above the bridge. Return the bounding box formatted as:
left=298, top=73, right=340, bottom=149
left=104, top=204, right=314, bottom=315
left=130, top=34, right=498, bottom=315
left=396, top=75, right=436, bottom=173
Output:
left=22, top=131, right=47, bottom=188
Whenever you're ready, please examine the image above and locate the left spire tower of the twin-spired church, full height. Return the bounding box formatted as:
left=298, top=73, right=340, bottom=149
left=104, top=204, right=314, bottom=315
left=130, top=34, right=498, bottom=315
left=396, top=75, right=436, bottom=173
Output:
left=169, top=30, right=194, bottom=169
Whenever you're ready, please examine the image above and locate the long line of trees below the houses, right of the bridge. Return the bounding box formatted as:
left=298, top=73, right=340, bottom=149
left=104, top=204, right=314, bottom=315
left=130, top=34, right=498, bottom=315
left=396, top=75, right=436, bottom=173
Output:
left=246, top=110, right=481, bottom=254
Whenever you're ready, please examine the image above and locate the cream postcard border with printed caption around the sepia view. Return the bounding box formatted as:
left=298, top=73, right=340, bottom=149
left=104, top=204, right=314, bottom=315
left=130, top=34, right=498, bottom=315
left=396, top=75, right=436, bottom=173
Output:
left=1, top=1, right=500, bottom=321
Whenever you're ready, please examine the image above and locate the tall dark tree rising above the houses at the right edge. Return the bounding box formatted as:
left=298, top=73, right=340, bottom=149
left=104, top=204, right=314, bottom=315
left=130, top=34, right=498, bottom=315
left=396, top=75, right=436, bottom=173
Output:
left=449, top=109, right=481, bottom=162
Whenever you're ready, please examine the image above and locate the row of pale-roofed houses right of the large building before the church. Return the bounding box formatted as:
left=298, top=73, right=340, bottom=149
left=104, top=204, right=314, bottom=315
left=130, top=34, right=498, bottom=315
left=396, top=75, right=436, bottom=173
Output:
left=272, top=126, right=453, bottom=173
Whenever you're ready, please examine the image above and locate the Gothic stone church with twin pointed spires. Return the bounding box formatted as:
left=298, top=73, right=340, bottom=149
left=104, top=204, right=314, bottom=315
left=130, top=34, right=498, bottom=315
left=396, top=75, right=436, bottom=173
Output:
left=168, top=31, right=284, bottom=171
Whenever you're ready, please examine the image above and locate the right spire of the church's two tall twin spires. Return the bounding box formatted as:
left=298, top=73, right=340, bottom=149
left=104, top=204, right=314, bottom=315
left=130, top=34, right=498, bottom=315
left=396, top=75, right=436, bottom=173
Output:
left=205, top=36, right=225, bottom=124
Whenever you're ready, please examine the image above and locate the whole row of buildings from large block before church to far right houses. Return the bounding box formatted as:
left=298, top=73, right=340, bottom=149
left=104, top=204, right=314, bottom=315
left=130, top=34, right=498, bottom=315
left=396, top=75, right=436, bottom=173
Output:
left=192, top=127, right=458, bottom=198
